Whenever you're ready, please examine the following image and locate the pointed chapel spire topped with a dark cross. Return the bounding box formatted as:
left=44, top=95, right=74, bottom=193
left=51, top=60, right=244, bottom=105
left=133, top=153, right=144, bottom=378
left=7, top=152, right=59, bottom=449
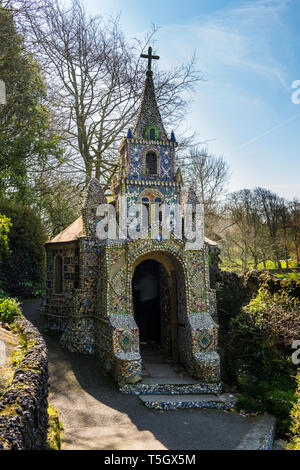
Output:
left=132, top=47, right=168, bottom=140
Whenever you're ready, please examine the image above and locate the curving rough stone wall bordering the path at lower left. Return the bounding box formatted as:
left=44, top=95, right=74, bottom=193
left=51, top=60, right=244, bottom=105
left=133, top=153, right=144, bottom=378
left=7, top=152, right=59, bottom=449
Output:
left=0, top=317, right=48, bottom=450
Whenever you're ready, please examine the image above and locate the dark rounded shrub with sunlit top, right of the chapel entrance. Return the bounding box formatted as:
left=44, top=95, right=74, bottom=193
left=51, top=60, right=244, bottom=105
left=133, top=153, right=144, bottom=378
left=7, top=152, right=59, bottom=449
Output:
left=225, top=288, right=300, bottom=382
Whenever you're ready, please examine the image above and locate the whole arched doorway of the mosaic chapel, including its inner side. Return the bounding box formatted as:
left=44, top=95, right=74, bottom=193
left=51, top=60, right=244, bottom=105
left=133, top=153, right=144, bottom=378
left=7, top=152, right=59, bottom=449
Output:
left=132, top=252, right=187, bottom=364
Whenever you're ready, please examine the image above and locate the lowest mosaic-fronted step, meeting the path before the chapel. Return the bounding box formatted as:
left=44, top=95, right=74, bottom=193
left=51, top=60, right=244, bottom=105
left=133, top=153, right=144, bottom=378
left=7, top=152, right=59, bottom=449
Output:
left=139, top=393, right=236, bottom=410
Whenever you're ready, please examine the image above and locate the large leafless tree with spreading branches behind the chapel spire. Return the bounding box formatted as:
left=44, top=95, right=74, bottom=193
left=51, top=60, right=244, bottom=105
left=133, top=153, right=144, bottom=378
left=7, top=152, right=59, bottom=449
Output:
left=16, top=0, right=201, bottom=186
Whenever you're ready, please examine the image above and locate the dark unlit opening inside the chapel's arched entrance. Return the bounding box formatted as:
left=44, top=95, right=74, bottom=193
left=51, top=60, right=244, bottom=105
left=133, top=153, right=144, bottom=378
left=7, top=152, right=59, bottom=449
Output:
left=132, top=260, right=161, bottom=344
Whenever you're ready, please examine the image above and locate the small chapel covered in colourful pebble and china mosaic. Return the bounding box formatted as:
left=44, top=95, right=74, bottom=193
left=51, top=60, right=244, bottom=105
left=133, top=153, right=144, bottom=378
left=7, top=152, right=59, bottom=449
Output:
left=45, top=49, right=220, bottom=392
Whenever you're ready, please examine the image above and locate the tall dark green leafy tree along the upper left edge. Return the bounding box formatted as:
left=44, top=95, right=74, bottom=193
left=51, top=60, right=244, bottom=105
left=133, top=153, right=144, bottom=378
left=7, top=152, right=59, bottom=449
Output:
left=0, top=1, right=61, bottom=201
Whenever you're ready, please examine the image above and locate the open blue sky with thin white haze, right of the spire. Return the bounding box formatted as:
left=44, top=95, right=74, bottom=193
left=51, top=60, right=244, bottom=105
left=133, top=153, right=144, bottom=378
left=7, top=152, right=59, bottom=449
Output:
left=83, top=0, right=300, bottom=199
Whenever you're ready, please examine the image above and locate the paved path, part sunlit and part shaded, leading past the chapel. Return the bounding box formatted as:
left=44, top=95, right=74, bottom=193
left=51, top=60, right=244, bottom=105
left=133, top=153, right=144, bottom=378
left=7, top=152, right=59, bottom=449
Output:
left=23, top=301, right=262, bottom=450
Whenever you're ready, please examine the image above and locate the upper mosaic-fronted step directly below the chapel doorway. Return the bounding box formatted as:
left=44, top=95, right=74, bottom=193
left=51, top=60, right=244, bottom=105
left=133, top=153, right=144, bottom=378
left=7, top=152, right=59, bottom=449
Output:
left=119, top=376, right=222, bottom=395
